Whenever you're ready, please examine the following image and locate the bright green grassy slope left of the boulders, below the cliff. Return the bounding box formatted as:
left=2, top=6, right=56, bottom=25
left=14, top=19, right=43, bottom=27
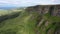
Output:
left=0, top=12, right=39, bottom=34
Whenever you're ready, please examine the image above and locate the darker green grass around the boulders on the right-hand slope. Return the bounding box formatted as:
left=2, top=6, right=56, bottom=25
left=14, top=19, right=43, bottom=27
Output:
left=39, top=13, right=60, bottom=34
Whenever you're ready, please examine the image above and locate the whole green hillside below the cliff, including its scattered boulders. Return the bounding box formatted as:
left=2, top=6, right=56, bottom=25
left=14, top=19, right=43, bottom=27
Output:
left=0, top=6, right=60, bottom=34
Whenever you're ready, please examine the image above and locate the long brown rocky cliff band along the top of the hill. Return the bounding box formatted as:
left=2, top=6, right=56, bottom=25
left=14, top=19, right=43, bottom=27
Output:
left=26, top=5, right=60, bottom=16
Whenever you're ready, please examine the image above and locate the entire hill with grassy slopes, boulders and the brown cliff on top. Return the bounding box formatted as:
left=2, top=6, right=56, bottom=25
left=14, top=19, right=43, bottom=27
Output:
left=0, top=5, right=60, bottom=34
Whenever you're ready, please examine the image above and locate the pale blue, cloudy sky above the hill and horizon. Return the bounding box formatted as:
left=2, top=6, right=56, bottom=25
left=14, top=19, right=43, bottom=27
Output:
left=0, top=0, right=60, bottom=7
